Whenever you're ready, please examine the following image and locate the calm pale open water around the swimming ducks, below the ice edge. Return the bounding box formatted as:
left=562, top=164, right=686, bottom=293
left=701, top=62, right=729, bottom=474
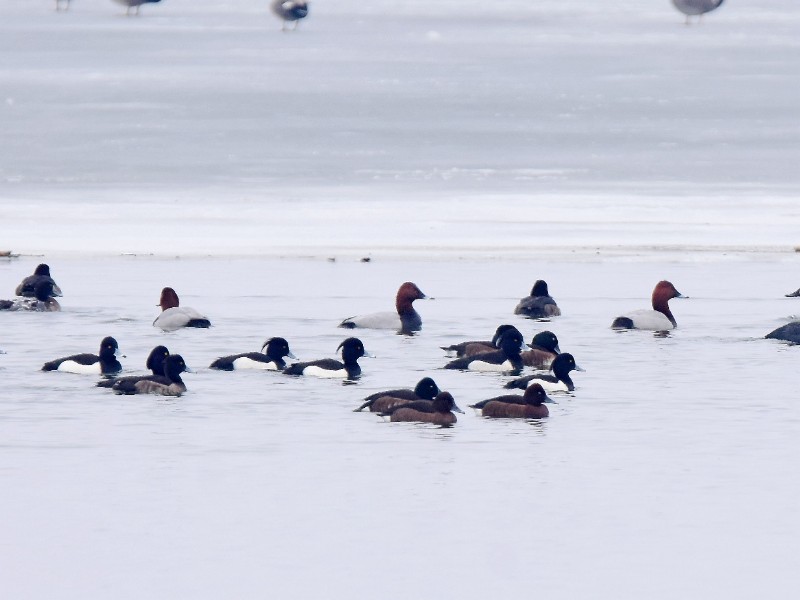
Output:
left=0, top=254, right=800, bottom=598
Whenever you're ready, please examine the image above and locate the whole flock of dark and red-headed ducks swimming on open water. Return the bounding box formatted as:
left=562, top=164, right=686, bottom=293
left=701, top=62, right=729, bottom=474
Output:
left=0, top=264, right=800, bottom=426
